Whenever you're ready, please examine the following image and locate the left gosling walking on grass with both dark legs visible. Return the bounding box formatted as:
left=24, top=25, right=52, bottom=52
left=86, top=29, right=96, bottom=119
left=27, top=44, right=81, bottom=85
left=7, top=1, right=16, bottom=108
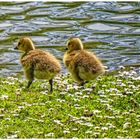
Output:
left=15, top=37, right=61, bottom=92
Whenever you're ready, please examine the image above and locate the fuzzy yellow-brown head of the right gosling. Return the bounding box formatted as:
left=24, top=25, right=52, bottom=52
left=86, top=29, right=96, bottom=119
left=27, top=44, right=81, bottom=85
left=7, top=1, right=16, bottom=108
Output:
left=66, top=38, right=83, bottom=51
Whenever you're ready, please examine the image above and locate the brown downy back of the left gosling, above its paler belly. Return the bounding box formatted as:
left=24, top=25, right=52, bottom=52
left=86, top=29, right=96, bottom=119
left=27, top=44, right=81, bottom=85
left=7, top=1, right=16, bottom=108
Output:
left=22, top=50, right=60, bottom=72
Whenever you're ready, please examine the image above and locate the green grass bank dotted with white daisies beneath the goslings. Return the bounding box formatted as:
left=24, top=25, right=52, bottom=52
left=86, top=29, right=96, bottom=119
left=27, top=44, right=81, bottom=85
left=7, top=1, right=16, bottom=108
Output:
left=0, top=70, right=140, bottom=138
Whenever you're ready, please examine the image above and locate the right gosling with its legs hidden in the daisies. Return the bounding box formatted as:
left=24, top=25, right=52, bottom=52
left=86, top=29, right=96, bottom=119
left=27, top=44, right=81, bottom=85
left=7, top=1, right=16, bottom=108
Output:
left=63, top=38, right=105, bottom=86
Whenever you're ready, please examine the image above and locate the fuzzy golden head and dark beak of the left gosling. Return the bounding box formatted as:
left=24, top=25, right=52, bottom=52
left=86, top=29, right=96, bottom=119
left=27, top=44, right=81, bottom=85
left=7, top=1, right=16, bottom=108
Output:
left=14, top=37, right=35, bottom=52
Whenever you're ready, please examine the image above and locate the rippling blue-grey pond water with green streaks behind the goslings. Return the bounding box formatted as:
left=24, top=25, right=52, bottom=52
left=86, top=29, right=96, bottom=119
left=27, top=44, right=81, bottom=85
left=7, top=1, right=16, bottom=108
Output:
left=0, top=1, right=140, bottom=75
